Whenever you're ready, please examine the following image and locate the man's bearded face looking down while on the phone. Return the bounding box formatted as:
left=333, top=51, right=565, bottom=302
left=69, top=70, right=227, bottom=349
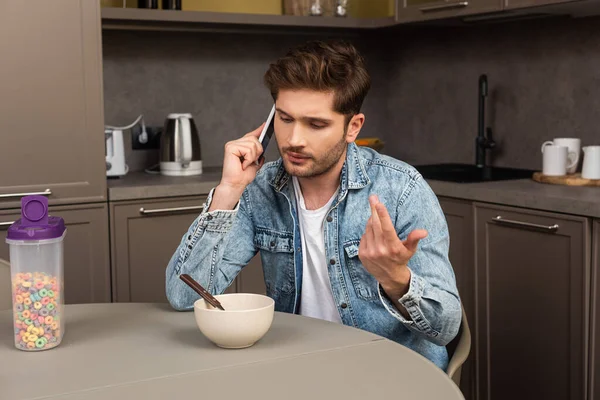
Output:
left=275, top=90, right=360, bottom=177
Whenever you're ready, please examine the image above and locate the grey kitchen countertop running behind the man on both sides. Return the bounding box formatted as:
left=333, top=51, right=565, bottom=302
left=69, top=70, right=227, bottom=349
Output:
left=108, top=168, right=600, bottom=218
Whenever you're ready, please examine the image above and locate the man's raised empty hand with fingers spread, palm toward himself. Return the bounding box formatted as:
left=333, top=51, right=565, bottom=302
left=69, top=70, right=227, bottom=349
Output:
left=358, top=195, right=427, bottom=318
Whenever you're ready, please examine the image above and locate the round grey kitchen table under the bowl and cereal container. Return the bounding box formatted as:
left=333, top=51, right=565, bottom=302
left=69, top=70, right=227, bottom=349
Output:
left=0, top=303, right=463, bottom=400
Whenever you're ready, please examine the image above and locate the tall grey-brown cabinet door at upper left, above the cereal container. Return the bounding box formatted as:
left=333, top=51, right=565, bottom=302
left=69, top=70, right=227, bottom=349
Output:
left=0, top=0, right=106, bottom=209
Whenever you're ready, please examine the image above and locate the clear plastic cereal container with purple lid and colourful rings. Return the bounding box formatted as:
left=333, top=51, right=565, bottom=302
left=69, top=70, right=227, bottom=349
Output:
left=6, top=196, right=66, bottom=351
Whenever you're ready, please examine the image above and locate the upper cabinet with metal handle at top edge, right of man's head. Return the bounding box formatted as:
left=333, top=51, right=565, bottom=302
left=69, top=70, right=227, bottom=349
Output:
left=396, top=0, right=504, bottom=23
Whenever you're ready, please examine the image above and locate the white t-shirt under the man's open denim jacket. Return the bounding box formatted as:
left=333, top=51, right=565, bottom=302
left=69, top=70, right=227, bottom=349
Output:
left=292, top=176, right=342, bottom=323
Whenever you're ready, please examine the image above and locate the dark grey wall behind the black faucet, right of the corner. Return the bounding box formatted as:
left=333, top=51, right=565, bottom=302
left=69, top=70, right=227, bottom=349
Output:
left=384, top=18, right=600, bottom=169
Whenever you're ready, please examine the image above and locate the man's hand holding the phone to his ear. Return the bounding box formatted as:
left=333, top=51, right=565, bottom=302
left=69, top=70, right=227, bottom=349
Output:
left=209, top=123, right=265, bottom=211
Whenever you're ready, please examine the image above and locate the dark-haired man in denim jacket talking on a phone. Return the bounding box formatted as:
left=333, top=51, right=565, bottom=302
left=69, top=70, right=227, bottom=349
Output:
left=166, top=41, right=461, bottom=369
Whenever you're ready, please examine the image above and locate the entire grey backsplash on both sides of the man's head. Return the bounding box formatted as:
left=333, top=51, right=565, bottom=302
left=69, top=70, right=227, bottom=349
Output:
left=103, top=18, right=600, bottom=170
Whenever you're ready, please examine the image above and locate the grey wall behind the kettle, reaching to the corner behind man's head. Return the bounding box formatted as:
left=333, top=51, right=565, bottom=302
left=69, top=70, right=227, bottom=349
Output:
left=103, top=31, right=388, bottom=170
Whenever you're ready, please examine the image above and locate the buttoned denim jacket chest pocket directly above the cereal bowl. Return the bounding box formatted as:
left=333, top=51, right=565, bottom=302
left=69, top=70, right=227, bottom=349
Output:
left=254, top=228, right=295, bottom=295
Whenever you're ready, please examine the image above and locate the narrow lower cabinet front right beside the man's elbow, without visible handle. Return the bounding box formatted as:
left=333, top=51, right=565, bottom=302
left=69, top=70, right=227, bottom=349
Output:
left=439, top=198, right=476, bottom=400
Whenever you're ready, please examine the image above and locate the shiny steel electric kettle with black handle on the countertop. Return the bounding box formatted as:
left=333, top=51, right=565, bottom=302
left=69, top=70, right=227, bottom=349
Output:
left=160, top=113, right=202, bottom=176
